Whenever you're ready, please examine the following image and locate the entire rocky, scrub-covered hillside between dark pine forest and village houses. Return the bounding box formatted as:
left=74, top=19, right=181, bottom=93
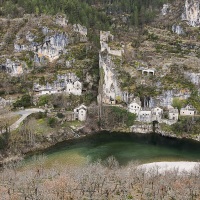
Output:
left=0, top=0, right=200, bottom=113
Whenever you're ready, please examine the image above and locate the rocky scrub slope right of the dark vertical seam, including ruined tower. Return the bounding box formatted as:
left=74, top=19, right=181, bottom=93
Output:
left=96, top=0, right=200, bottom=111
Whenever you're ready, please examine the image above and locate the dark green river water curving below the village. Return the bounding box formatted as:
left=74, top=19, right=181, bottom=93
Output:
left=26, top=132, right=200, bottom=166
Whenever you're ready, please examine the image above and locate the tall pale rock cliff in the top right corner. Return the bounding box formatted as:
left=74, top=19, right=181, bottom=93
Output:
left=182, top=0, right=200, bottom=26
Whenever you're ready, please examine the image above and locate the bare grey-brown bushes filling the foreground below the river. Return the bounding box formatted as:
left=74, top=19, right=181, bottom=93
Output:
left=0, top=158, right=200, bottom=200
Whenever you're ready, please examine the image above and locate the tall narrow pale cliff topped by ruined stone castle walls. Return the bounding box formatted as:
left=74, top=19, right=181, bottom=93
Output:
left=99, top=31, right=132, bottom=104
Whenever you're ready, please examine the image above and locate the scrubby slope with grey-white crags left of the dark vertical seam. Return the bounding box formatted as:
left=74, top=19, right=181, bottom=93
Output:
left=0, top=15, right=98, bottom=104
